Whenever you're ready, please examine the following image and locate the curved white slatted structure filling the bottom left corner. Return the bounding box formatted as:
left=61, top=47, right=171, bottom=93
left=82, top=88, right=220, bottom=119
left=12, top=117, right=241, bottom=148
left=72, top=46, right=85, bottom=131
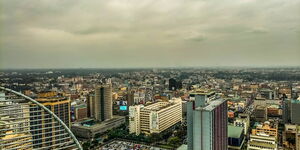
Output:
left=0, top=87, right=82, bottom=150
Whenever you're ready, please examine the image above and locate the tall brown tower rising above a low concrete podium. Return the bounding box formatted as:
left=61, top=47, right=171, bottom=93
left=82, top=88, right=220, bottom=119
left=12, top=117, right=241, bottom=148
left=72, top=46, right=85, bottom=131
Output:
left=93, top=84, right=112, bottom=121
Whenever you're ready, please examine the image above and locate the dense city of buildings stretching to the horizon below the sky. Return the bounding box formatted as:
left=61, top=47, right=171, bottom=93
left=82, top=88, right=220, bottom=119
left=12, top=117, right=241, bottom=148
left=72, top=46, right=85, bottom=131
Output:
left=0, top=67, right=300, bottom=150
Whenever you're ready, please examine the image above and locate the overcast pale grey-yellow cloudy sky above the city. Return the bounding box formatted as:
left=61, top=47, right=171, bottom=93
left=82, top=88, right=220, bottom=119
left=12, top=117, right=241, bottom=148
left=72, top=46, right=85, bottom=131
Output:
left=0, top=0, right=300, bottom=68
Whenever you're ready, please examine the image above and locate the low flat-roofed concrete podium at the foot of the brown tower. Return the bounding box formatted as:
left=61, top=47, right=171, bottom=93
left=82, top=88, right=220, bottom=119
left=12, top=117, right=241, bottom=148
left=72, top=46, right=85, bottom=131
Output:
left=71, top=116, right=125, bottom=139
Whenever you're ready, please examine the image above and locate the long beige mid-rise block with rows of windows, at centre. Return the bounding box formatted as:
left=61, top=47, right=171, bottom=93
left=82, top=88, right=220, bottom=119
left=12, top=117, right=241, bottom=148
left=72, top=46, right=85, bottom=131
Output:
left=129, top=99, right=182, bottom=135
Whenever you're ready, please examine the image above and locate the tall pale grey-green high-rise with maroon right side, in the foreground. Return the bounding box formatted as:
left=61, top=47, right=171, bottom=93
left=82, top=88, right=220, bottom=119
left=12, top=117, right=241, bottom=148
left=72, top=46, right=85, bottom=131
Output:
left=187, top=92, right=228, bottom=150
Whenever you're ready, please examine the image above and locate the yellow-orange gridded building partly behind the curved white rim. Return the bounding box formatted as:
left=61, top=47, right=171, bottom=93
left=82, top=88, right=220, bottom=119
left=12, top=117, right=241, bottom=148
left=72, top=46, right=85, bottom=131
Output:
left=30, top=97, right=71, bottom=148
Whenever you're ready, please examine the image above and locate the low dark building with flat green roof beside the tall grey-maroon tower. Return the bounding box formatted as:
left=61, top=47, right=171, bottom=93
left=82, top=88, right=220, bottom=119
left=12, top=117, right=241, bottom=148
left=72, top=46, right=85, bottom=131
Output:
left=228, top=125, right=245, bottom=150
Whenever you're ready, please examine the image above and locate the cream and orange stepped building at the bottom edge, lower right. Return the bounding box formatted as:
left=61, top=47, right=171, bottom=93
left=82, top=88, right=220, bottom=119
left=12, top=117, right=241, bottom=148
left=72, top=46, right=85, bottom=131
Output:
left=247, top=121, right=278, bottom=150
